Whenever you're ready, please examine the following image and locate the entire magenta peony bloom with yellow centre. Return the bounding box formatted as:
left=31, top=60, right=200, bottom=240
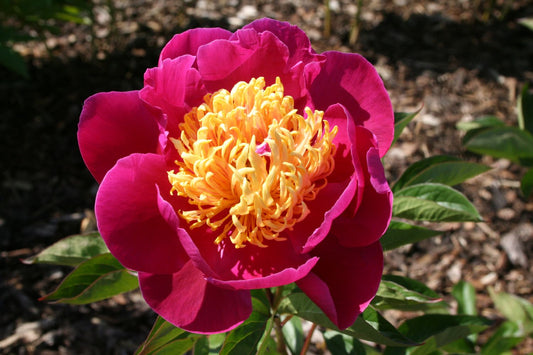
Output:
left=78, top=19, right=394, bottom=334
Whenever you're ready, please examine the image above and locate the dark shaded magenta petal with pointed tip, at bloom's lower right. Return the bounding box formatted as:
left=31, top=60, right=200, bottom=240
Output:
left=296, top=236, right=383, bottom=329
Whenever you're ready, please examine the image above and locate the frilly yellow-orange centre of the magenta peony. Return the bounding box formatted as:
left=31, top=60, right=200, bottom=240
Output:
left=168, top=77, right=337, bottom=248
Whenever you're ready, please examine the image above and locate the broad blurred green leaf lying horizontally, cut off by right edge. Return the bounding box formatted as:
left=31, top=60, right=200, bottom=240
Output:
left=465, top=127, right=533, bottom=163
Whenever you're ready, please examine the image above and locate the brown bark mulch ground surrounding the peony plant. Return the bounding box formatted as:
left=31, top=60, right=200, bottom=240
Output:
left=0, top=0, right=533, bottom=354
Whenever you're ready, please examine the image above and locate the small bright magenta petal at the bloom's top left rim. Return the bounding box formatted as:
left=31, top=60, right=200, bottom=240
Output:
left=159, top=28, right=233, bottom=64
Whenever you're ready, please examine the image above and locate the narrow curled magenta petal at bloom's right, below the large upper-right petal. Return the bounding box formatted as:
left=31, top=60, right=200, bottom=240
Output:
left=332, top=127, right=393, bottom=247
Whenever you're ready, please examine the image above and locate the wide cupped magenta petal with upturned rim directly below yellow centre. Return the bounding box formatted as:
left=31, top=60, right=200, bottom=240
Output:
left=158, top=195, right=318, bottom=290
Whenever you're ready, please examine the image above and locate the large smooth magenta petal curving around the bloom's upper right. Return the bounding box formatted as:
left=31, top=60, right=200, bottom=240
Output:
left=309, top=51, right=394, bottom=157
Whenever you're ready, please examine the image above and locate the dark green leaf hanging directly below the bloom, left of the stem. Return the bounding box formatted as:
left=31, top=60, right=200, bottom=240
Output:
left=220, top=290, right=270, bottom=355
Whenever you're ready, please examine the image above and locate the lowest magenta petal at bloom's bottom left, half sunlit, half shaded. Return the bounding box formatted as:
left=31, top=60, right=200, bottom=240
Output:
left=139, top=262, right=252, bottom=334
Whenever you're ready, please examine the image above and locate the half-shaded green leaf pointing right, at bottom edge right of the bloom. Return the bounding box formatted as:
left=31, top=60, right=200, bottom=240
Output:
left=384, top=314, right=491, bottom=355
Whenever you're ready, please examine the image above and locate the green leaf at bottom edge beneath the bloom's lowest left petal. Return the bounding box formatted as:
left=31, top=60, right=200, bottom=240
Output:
left=135, top=316, right=199, bottom=355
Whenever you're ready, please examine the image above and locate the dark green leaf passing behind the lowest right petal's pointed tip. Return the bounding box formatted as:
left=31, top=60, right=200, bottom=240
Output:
left=278, top=292, right=416, bottom=346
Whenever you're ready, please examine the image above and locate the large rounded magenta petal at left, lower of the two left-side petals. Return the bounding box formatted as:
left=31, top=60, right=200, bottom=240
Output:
left=95, top=154, right=188, bottom=273
